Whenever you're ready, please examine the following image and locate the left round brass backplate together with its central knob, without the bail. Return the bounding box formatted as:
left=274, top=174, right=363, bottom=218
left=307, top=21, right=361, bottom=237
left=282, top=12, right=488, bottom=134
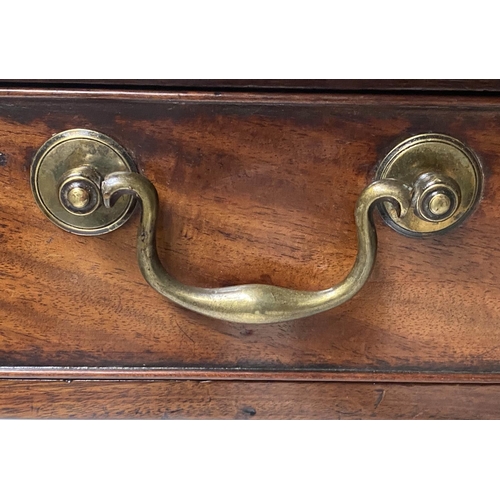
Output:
left=31, top=129, right=137, bottom=235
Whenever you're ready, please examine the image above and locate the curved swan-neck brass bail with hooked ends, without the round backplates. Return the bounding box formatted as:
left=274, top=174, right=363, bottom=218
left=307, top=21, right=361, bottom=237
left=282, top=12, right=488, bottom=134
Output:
left=102, top=172, right=411, bottom=323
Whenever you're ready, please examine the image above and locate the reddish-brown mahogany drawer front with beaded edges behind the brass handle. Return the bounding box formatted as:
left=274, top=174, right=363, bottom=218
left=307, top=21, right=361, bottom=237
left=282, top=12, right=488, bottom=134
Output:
left=0, top=90, right=500, bottom=382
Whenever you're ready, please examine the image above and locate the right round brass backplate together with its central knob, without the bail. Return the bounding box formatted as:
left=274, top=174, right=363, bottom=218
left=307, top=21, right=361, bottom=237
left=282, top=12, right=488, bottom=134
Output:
left=376, top=134, right=483, bottom=236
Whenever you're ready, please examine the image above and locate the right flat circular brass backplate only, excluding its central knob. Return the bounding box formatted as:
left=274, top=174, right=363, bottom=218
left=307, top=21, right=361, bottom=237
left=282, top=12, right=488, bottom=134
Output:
left=376, top=134, right=483, bottom=236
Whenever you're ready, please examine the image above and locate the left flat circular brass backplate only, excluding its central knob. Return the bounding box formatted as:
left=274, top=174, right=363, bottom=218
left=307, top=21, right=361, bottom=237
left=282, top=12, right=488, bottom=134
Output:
left=31, top=129, right=137, bottom=236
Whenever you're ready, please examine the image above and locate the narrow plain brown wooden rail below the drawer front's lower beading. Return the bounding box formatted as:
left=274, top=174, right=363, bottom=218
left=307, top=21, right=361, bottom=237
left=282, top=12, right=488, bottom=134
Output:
left=0, top=380, right=500, bottom=420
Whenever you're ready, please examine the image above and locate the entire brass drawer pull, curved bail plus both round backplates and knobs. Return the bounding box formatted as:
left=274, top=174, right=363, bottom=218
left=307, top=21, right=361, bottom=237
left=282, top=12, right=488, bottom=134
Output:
left=31, top=130, right=482, bottom=324
